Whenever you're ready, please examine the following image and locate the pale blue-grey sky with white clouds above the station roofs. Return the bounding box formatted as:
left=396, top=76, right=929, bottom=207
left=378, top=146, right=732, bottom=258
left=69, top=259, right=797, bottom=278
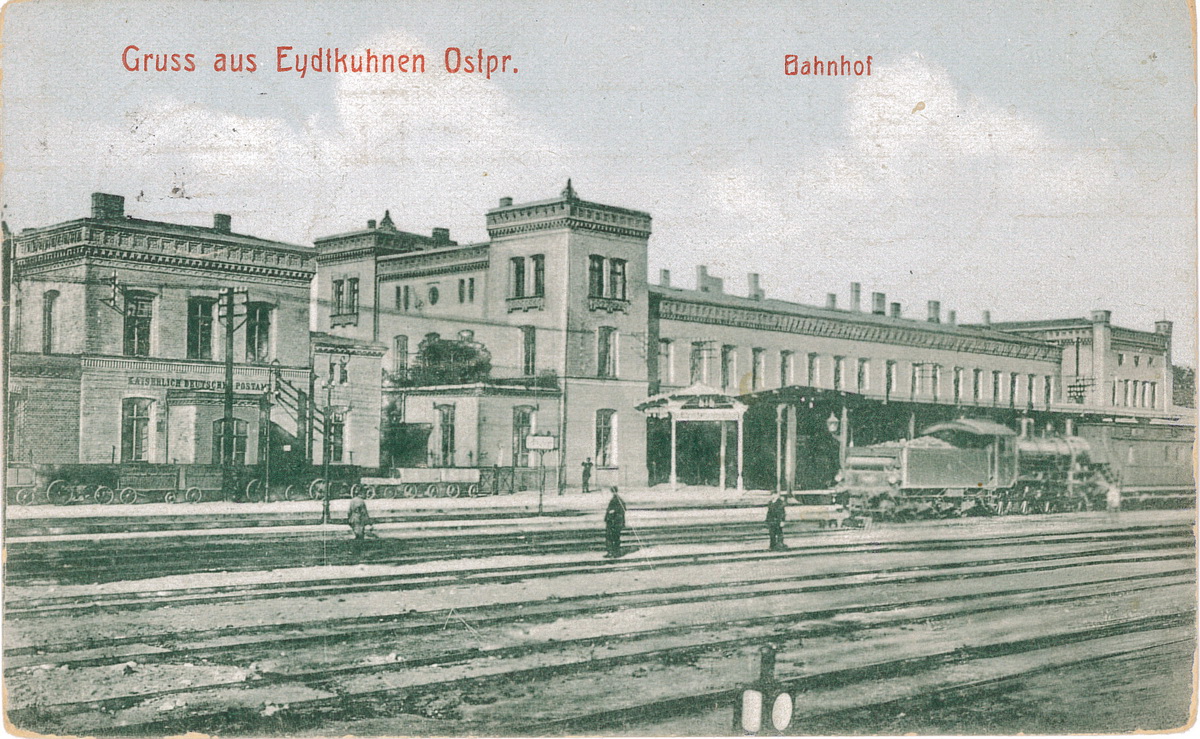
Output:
left=0, top=0, right=1196, bottom=365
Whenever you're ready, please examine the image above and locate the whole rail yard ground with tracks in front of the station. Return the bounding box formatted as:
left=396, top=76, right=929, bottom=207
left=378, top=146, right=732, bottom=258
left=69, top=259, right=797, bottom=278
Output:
left=4, top=491, right=1196, bottom=735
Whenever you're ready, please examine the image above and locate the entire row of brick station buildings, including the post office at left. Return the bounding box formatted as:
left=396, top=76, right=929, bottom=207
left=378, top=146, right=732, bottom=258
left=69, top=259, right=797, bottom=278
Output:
left=6, top=182, right=1192, bottom=487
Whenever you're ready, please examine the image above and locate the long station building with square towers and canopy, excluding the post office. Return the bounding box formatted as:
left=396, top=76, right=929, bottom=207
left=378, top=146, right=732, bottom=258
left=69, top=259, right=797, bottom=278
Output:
left=316, top=182, right=1187, bottom=486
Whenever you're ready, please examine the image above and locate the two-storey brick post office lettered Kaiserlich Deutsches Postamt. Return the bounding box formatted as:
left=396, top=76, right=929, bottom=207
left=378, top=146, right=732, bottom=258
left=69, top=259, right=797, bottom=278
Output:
left=5, top=193, right=316, bottom=464
